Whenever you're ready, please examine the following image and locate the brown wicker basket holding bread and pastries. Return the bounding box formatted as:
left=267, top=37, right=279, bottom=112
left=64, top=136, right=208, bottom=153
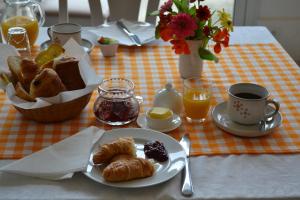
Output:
left=14, top=93, right=91, bottom=123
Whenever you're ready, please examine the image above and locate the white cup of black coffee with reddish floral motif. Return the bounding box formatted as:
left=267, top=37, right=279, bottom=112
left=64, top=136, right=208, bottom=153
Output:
left=227, top=83, right=280, bottom=125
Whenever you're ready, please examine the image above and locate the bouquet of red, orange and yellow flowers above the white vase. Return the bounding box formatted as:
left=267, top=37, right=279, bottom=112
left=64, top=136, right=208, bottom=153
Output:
left=151, top=0, right=233, bottom=62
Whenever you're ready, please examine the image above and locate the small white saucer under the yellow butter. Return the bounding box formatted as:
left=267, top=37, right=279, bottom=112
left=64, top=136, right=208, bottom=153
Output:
left=136, top=113, right=181, bottom=132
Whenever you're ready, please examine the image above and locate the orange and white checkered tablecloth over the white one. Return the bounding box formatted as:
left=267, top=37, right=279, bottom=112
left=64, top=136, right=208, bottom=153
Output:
left=0, top=43, right=300, bottom=159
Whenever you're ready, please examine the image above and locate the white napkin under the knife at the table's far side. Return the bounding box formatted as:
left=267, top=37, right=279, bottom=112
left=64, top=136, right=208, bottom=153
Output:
left=89, top=19, right=155, bottom=46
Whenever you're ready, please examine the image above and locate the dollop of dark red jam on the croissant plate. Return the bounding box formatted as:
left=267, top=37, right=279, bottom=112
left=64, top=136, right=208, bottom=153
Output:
left=144, top=141, right=169, bottom=162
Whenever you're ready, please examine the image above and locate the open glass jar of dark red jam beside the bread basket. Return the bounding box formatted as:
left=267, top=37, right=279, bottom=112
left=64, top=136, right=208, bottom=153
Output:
left=94, top=78, right=140, bottom=125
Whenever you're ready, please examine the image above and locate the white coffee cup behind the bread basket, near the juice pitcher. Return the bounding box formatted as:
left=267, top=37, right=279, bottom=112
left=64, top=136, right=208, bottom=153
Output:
left=47, top=23, right=81, bottom=45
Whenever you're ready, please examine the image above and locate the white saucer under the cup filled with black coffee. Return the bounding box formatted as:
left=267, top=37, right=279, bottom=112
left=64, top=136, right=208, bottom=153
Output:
left=211, top=102, right=282, bottom=137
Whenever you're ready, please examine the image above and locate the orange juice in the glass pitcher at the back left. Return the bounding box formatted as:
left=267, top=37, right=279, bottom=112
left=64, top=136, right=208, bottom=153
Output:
left=1, top=16, right=39, bottom=46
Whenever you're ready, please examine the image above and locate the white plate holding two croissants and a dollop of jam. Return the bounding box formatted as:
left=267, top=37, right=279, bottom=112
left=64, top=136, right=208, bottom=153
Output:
left=84, top=128, right=186, bottom=188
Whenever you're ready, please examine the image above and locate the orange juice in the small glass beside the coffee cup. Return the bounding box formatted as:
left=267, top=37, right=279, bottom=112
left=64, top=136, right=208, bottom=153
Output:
left=183, top=89, right=211, bottom=120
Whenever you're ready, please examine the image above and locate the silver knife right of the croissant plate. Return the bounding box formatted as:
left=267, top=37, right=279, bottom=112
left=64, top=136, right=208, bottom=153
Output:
left=179, top=134, right=194, bottom=196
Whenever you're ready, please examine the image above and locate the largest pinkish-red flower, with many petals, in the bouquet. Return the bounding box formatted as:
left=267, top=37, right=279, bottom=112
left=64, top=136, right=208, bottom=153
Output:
left=170, top=13, right=198, bottom=39
